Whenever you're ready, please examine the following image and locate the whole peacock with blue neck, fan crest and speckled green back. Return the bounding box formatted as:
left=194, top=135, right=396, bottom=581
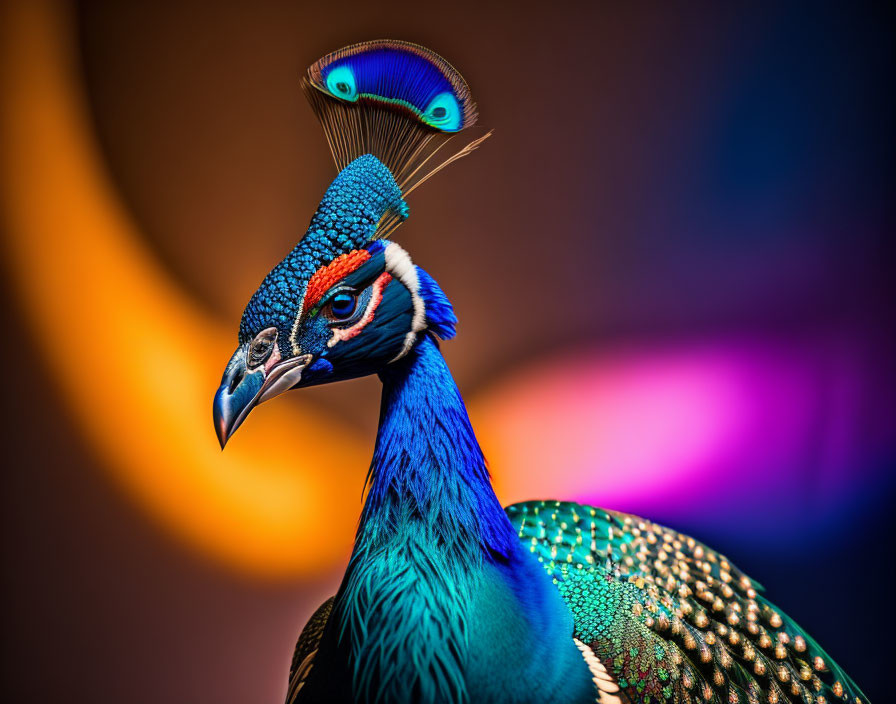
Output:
left=213, top=40, right=867, bottom=704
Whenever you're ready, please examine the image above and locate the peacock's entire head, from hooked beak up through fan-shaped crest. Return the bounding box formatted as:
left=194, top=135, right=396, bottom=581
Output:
left=214, top=40, right=490, bottom=447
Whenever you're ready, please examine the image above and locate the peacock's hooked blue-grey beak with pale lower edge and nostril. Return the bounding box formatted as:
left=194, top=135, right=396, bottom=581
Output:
left=212, top=344, right=311, bottom=450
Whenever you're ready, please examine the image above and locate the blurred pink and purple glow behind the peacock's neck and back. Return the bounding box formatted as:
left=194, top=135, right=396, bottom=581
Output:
left=478, top=338, right=889, bottom=533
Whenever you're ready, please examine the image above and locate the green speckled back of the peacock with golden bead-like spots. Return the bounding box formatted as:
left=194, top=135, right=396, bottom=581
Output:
left=506, top=501, right=867, bottom=704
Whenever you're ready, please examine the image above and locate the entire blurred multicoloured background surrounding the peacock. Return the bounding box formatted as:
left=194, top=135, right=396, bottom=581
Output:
left=0, top=0, right=896, bottom=704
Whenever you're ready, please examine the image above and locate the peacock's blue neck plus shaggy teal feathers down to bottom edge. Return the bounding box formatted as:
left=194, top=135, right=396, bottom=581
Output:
left=316, top=337, right=519, bottom=703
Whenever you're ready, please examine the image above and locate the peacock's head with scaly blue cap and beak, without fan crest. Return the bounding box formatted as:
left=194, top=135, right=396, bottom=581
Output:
left=214, top=154, right=457, bottom=448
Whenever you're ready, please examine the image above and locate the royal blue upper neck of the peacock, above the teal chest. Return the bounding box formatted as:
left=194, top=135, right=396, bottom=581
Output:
left=355, top=337, right=517, bottom=563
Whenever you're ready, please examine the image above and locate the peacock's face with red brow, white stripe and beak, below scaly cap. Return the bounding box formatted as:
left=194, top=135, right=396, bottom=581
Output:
left=208, top=240, right=454, bottom=447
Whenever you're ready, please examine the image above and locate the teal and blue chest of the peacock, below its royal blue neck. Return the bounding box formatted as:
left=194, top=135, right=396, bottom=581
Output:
left=302, top=544, right=595, bottom=704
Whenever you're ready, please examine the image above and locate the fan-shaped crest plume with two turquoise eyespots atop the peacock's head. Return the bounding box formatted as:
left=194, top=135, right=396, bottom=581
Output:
left=302, top=39, right=491, bottom=237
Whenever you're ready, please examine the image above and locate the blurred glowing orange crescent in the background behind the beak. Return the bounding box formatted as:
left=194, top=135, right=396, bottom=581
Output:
left=0, top=1, right=370, bottom=577
